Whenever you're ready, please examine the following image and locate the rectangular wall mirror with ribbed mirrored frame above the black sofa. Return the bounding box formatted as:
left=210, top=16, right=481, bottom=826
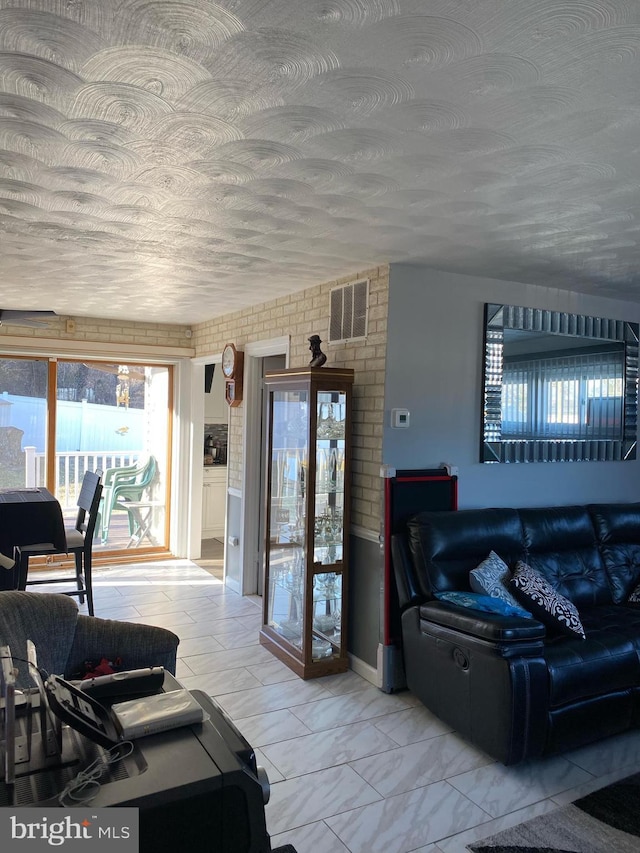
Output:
left=480, top=303, right=638, bottom=463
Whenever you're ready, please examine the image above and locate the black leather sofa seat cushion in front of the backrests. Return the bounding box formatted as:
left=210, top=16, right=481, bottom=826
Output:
left=545, top=604, right=640, bottom=708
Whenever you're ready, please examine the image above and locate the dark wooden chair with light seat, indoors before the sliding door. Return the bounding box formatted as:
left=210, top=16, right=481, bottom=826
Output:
left=14, top=471, right=102, bottom=616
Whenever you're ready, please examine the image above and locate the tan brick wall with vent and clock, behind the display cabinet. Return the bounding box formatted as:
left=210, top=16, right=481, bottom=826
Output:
left=191, top=266, right=389, bottom=533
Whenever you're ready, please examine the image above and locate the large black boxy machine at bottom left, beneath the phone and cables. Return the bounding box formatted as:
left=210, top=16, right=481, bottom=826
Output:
left=0, top=673, right=271, bottom=853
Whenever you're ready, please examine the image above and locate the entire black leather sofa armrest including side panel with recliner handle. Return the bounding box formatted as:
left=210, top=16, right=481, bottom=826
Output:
left=402, top=602, right=549, bottom=764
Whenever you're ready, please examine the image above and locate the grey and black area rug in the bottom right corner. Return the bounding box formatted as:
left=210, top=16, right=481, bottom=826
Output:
left=468, top=773, right=640, bottom=853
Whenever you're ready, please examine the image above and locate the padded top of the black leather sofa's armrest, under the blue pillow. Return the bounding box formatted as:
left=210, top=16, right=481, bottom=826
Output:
left=420, top=601, right=546, bottom=643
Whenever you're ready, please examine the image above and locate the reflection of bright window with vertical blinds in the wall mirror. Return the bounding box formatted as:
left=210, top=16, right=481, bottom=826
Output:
left=502, top=351, right=624, bottom=439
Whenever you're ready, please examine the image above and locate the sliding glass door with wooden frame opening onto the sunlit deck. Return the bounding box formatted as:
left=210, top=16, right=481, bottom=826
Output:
left=0, top=358, right=172, bottom=552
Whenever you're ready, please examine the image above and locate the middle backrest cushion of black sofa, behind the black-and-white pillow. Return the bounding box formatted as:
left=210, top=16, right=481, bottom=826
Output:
left=520, top=506, right=612, bottom=607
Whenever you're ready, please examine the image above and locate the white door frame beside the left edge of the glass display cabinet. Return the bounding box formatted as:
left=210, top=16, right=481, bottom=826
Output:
left=239, top=335, right=291, bottom=595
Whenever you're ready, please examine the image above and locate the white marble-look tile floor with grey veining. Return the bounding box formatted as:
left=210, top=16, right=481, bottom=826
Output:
left=30, top=560, right=640, bottom=853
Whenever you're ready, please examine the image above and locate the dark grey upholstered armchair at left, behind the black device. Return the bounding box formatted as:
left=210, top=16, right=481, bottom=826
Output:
left=0, top=591, right=179, bottom=687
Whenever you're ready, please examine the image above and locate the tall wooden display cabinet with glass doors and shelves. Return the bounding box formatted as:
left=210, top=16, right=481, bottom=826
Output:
left=260, top=367, right=353, bottom=678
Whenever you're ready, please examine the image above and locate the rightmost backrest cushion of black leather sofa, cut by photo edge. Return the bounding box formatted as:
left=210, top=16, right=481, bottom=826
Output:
left=588, top=503, right=640, bottom=604
